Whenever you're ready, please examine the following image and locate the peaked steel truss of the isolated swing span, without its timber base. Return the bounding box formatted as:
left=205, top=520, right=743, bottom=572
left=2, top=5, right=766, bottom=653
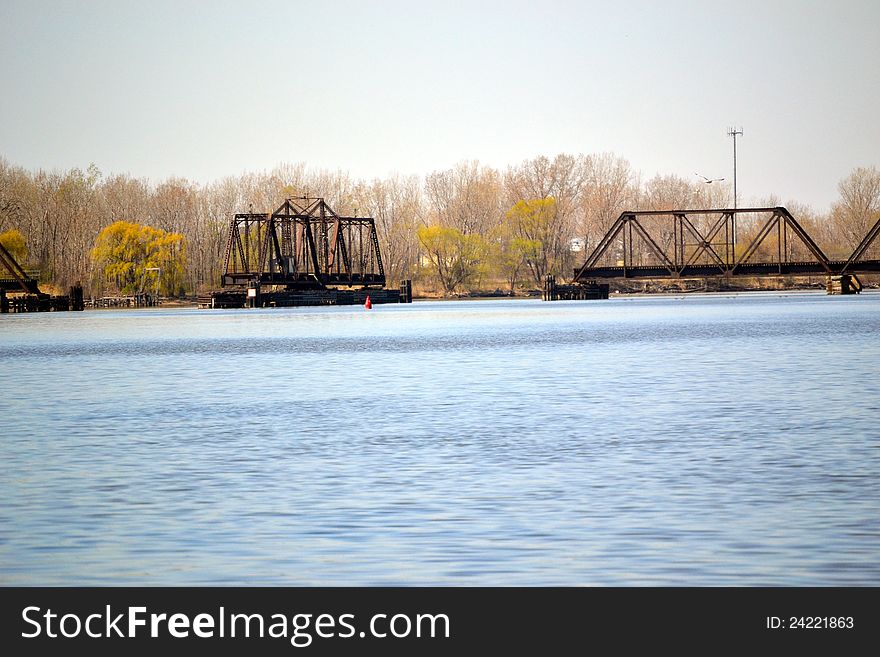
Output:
left=222, top=196, right=385, bottom=290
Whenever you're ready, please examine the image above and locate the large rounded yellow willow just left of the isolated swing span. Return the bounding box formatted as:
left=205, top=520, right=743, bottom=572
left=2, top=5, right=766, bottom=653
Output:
left=92, top=221, right=186, bottom=296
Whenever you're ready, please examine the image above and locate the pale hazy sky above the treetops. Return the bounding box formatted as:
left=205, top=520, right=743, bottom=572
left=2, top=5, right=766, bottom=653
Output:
left=0, top=0, right=880, bottom=212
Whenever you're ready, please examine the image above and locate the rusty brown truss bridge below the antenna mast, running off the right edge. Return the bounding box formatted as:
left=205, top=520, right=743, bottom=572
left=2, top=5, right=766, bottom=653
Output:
left=574, top=207, right=880, bottom=283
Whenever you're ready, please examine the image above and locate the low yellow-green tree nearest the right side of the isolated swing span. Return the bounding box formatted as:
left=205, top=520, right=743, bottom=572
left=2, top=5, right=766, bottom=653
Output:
left=418, top=225, right=487, bottom=294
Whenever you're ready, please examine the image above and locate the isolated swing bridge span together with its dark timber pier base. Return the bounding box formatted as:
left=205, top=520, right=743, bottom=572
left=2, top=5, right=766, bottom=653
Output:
left=207, top=197, right=412, bottom=308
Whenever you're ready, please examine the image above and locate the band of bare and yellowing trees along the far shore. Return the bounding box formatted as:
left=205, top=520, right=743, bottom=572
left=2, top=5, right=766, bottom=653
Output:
left=0, top=153, right=880, bottom=295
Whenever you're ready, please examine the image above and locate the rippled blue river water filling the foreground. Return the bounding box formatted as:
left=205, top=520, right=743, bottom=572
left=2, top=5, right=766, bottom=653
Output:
left=0, top=293, right=880, bottom=586
